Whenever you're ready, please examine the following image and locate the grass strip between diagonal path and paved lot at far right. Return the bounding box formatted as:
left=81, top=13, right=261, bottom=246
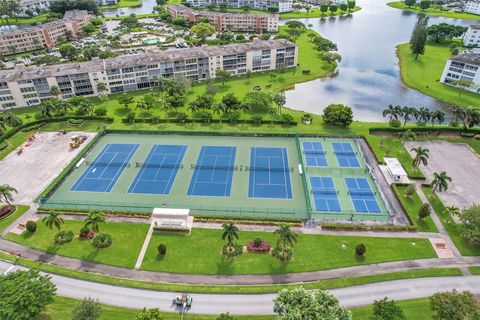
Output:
left=422, top=187, right=480, bottom=256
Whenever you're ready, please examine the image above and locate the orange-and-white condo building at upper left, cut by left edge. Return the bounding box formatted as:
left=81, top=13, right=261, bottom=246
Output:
left=0, top=10, right=92, bottom=56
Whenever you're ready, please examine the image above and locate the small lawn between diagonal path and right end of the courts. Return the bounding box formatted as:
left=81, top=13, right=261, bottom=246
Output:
left=393, top=185, right=438, bottom=232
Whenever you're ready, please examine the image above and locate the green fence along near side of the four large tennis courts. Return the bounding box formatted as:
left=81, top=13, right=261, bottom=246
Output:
left=42, top=199, right=308, bottom=219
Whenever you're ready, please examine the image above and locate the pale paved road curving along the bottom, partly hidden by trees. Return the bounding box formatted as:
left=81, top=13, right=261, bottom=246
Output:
left=0, top=261, right=480, bottom=314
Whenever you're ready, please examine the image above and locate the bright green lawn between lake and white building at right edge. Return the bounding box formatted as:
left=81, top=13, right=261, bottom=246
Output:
left=397, top=41, right=480, bottom=107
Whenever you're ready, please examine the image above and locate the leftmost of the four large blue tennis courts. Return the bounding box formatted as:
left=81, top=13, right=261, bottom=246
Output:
left=71, top=143, right=139, bottom=192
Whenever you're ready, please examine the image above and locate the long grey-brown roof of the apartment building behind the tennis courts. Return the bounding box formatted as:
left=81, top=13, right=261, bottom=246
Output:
left=0, top=39, right=296, bottom=82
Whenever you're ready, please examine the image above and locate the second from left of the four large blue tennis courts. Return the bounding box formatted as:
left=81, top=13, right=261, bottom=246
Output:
left=128, top=144, right=187, bottom=194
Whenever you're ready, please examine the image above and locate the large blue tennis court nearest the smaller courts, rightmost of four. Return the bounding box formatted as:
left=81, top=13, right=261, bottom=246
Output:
left=246, top=147, right=293, bottom=199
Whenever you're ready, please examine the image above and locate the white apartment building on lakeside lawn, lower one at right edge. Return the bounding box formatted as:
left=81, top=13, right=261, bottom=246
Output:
left=440, top=52, right=480, bottom=92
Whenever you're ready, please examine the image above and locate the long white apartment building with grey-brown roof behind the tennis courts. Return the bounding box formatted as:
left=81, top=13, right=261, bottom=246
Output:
left=0, top=39, right=298, bottom=110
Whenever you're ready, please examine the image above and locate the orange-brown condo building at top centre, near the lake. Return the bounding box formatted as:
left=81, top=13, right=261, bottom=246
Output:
left=165, top=4, right=279, bottom=33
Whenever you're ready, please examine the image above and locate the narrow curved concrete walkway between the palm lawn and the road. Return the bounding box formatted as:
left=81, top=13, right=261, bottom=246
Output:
left=0, top=240, right=480, bottom=285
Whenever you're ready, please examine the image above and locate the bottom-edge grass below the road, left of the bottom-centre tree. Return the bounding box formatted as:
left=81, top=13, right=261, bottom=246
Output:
left=35, top=297, right=274, bottom=320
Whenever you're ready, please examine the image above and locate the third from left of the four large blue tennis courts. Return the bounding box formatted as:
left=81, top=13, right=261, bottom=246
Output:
left=187, top=146, right=237, bottom=197
